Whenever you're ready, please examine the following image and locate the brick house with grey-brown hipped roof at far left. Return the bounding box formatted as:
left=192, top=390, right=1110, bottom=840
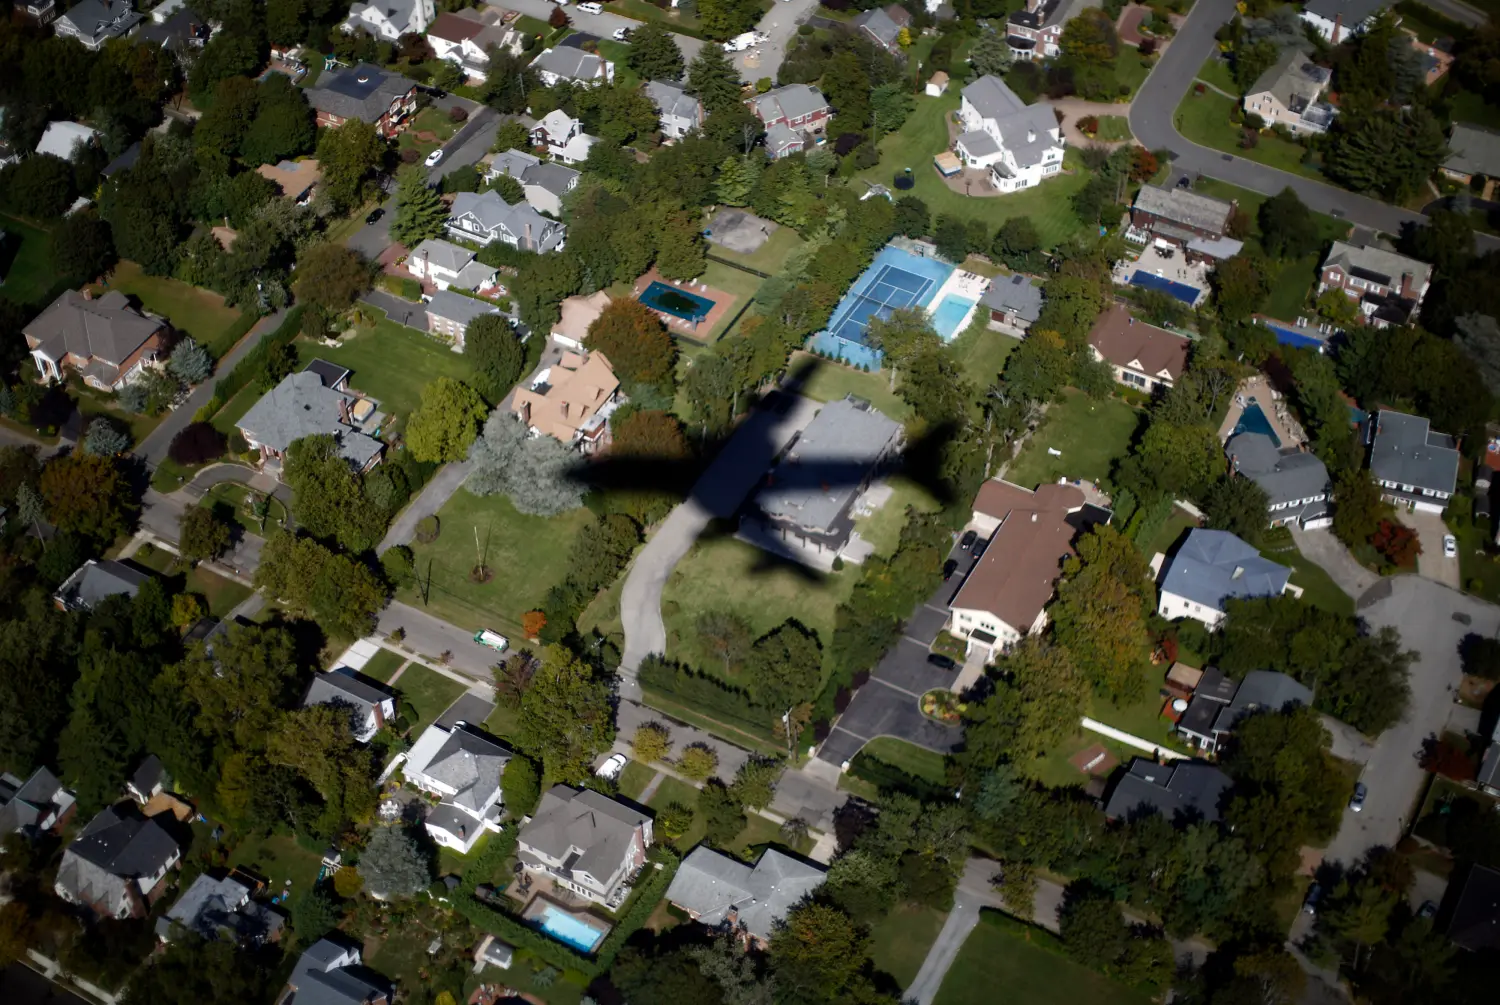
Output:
left=21, top=290, right=168, bottom=392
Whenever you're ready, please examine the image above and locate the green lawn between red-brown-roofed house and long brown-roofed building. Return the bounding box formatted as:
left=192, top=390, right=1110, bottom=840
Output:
left=1005, top=387, right=1145, bottom=489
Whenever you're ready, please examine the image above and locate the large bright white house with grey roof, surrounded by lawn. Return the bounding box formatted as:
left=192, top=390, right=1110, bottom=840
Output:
left=953, top=74, right=1062, bottom=192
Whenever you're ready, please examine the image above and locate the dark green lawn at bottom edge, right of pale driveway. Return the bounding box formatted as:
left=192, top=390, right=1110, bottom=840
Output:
left=935, top=911, right=1151, bottom=1005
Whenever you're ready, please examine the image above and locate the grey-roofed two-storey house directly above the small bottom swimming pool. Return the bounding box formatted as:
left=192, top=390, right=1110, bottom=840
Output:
left=516, top=785, right=651, bottom=911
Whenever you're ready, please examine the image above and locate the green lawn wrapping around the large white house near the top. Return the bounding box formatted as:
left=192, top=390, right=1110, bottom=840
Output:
left=858, top=87, right=1089, bottom=248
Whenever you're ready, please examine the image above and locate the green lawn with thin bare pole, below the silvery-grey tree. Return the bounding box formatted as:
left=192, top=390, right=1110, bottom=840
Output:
left=401, top=489, right=593, bottom=636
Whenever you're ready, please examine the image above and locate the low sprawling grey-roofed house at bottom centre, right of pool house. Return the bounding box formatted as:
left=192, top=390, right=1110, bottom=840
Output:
left=666, top=845, right=827, bottom=947
